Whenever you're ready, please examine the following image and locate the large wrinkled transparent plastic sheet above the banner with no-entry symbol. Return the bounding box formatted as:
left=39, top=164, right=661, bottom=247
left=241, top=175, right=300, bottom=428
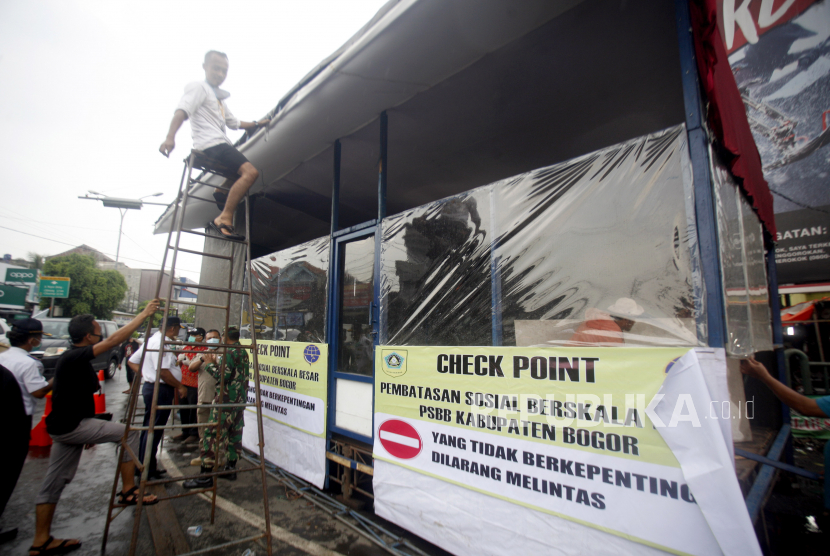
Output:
left=380, top=126, right=706, bottom=346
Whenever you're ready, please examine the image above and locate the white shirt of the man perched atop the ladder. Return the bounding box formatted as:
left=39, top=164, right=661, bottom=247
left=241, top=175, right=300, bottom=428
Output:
left=176, top=81, right=239, bottom=151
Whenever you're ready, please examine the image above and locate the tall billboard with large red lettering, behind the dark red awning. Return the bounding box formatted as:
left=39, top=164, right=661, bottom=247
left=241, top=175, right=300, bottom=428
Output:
left=718, top=0, right=830, bottom=283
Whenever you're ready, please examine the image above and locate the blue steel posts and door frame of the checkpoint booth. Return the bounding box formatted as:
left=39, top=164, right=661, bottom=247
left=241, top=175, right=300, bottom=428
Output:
left=326, top=0, right=791, bottom=536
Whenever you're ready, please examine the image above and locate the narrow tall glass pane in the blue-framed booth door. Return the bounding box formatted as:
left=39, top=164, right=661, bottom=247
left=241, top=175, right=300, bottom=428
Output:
left=337, top=236, right=375, bottom=376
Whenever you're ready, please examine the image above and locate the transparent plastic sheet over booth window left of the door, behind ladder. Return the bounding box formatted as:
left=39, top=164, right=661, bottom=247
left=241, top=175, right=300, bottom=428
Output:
left=242, top=237, right=330, bottom=343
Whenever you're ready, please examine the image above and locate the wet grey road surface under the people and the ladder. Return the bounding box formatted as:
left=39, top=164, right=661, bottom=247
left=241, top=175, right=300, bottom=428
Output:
left=0, top=364, right=414, bottom=556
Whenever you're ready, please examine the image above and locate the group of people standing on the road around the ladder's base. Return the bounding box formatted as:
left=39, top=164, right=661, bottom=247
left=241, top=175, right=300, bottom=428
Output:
left=0, top=300, right=250, bottom=556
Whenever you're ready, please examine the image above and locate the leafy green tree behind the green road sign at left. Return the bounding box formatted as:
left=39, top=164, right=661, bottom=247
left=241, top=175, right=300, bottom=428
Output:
left=40, top=253, right=127, bottom=320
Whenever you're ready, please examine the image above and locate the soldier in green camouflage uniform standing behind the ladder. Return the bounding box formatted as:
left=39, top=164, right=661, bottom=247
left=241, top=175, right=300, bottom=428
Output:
left=183, top=328, right=250, bottom=488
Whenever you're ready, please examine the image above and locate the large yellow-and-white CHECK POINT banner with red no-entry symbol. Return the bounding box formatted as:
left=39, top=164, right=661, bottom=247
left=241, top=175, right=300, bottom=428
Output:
left=374, top=346, right=760, bottom=556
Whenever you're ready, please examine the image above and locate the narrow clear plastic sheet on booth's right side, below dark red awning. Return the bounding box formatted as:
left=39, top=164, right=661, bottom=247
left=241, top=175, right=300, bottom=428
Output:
left=712, top=154, right=772, bottom=356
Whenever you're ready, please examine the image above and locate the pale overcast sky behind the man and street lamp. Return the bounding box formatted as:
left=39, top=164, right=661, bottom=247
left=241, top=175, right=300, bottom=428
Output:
left=0, top=0, right=386, bottom=281
